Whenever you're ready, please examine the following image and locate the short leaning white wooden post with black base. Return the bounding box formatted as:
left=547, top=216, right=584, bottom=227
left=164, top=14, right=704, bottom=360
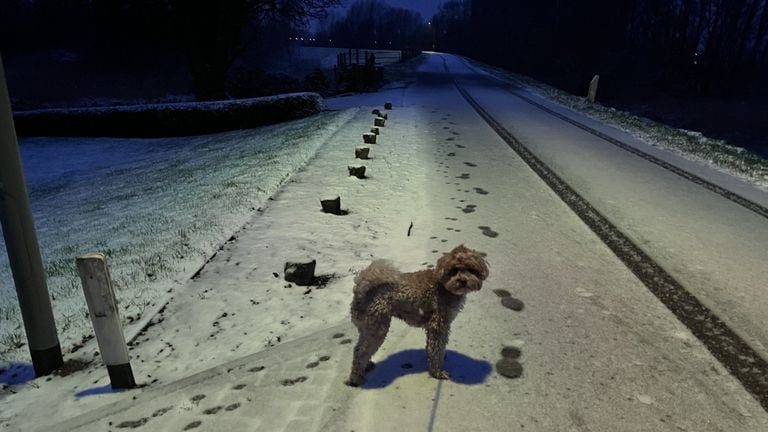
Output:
left=77, top=253, right=136, bottom=388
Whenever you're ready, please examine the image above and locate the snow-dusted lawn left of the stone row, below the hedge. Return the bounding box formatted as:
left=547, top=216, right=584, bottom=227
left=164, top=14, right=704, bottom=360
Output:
left=0, top=111, right=353, bottom=361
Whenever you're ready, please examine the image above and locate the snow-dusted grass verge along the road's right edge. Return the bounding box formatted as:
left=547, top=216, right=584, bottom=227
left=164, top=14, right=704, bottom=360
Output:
left=466, top=58, right=768, bottom=190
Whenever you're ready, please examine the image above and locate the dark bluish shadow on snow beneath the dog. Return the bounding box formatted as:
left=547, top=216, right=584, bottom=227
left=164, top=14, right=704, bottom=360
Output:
left=362, top=349, right=493, bottom=389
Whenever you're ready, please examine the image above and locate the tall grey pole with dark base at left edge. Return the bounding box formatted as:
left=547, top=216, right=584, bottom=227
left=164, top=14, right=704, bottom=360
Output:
left=0, top=52, right=64, bottom=376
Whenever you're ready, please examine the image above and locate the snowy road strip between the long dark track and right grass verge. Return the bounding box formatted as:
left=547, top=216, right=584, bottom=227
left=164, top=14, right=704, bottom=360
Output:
left=438, top=53, right=768, bottom=392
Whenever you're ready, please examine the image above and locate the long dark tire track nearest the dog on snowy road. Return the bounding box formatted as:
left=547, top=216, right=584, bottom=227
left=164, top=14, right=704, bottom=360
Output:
left=443, top=59, right=768, bottom=411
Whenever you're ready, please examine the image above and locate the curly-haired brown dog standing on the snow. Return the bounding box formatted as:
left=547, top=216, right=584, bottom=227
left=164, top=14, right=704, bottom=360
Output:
left=347, top=245, right=488, bottom=386
